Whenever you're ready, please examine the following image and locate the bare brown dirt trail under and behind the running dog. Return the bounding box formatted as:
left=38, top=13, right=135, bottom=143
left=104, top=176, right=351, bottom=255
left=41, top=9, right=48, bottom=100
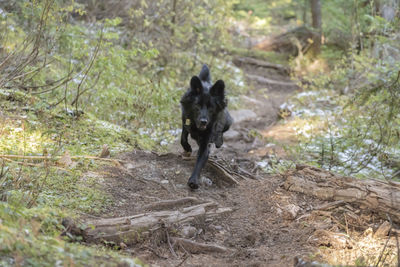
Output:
left=98, top=58, right=324, bottom=266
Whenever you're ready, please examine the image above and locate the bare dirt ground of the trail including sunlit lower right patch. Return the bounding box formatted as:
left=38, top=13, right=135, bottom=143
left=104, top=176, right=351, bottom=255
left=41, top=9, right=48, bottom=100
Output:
left=90, top=54, right=396, bottom=267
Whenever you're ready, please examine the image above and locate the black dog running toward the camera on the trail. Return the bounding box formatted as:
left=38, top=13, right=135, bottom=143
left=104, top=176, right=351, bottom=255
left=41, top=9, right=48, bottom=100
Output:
left=181, top=65, right=233, bottom=189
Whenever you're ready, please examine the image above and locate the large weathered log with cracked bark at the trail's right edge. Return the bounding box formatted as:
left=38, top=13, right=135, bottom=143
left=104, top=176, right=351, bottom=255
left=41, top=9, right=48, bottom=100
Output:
left=283, top=165, right=400, bottom=222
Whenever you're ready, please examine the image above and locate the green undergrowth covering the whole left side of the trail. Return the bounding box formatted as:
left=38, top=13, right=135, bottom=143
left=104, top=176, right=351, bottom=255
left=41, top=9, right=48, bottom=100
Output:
left=0, top=0, right=246, bottom=266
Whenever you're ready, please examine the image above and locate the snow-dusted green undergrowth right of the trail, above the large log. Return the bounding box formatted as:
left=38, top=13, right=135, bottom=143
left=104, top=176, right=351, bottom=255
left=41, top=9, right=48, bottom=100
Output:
left=276, top=33, right=400, bottom=179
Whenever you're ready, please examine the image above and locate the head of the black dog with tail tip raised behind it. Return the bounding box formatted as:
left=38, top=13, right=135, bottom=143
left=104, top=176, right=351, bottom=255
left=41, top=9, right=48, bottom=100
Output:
left=181, top=65, right=226, bottom=131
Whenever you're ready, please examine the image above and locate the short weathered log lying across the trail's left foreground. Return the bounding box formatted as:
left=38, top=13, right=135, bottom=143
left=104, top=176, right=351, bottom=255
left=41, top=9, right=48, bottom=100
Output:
left=72, top=201, right=232, bottom=245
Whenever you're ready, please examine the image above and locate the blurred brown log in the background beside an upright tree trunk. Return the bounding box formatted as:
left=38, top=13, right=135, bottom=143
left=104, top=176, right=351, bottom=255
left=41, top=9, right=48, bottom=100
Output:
left=255, top=26, right=315, bottom=56
